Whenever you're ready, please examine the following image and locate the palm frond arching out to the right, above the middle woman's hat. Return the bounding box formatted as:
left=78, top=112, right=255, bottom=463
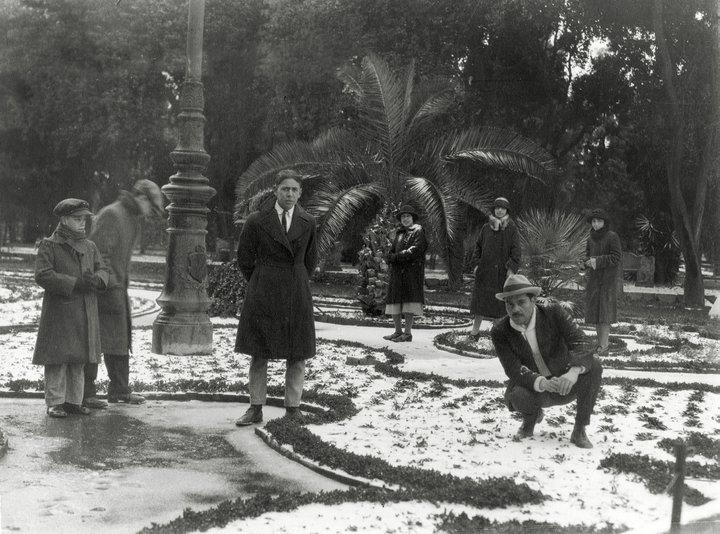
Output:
left=436, top=128, right=557, bottom=182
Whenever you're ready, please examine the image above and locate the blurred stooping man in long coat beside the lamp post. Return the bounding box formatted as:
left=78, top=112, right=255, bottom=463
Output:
left=83, top=179, right=164, bottom=409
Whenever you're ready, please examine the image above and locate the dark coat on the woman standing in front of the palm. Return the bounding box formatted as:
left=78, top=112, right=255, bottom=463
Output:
left=385, top=224, right=427, bottom=304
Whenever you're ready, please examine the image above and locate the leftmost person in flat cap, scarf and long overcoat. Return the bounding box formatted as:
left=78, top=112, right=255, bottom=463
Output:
left=33, top=198, right=109, bottom=417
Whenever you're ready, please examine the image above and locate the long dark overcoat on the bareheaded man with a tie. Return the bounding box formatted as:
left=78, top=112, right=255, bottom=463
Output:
left=235, top=204, right=317, bottom=361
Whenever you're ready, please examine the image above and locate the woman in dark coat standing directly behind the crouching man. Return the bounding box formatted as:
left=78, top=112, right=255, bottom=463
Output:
left=469, top=197, right=521, bottom=341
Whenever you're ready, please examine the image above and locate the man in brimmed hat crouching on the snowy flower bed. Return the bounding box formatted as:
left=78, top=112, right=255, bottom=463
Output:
left=490, top=275, right=602, bottom=449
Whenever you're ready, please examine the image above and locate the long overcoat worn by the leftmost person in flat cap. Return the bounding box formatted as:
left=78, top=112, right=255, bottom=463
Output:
left=33, top=232, right=108, bottom=365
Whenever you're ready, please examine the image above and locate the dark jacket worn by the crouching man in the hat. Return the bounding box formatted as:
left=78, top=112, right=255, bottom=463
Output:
left=490, top=304, right=593, bottom=391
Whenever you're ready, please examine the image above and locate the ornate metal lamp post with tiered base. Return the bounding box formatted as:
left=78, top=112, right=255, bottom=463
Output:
left=152, top=0, right=215, bottom=355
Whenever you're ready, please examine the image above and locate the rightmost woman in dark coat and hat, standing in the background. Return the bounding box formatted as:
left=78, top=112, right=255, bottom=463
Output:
left=585, top=209, right=622, bottom=354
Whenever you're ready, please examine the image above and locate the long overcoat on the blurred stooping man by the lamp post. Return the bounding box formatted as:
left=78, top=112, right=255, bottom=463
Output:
left=90, top=191, right=141, bottom=356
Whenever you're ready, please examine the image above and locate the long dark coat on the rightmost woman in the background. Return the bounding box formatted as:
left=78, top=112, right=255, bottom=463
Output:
left=585, top=228, right=622, bottom=324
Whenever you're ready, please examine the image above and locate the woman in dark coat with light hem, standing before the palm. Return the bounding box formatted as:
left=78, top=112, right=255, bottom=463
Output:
left=383, top=205, right=427, bottom=342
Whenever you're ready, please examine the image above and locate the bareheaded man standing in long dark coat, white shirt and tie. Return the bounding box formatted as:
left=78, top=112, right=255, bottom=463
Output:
left=235, top=170, right=317, bottom=426
